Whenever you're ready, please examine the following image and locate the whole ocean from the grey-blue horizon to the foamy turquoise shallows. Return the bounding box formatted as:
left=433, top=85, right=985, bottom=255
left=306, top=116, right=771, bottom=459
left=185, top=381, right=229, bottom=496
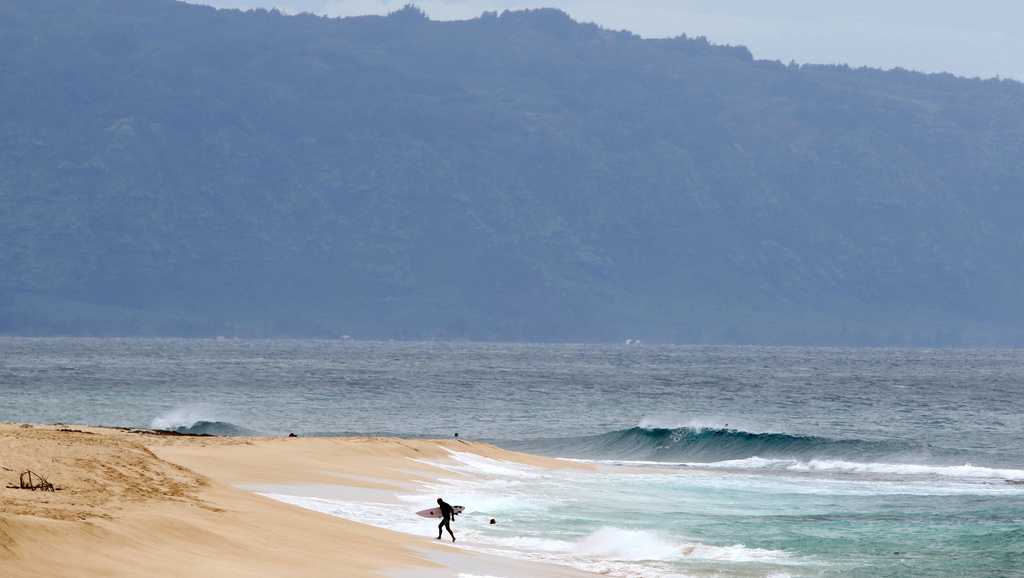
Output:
left=0, top=337, right=1024, bottom=578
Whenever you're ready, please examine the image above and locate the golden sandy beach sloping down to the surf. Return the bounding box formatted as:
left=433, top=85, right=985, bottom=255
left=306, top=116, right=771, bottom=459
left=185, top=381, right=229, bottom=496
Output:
left=0, top=424, right=584, bottom=578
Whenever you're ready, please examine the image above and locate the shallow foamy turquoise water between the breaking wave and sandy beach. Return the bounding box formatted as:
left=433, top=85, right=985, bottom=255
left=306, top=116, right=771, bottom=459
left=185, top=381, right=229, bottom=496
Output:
left=262, top=446, right=1024, bottom=577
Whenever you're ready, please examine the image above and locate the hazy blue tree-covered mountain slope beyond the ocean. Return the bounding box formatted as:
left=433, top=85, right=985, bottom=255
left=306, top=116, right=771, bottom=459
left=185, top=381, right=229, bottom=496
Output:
left=0, top=0, right=1024, bottom=344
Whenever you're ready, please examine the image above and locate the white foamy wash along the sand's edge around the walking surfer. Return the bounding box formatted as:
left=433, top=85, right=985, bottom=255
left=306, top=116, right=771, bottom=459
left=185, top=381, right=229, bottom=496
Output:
left=258, top=451, right=800, bottom=577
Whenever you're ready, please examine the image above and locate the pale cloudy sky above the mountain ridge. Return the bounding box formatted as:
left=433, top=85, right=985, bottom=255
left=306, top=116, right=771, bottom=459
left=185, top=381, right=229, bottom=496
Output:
left=191, top=0, right=1024, bottom=80
